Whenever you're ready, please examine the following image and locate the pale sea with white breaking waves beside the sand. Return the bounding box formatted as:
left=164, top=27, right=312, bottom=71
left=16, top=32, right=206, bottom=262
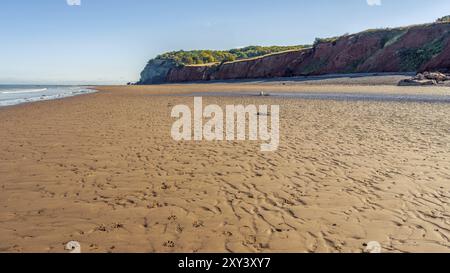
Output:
left=0, top=85, right=96, bottom=107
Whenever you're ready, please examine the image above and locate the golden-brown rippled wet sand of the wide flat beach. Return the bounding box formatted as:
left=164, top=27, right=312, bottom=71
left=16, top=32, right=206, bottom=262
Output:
left=0, top=83, right=450, bottom=252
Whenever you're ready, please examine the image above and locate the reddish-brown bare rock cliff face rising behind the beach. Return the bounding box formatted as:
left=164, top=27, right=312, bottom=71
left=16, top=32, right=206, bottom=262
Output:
left=140, top=23, right=450, bottom=84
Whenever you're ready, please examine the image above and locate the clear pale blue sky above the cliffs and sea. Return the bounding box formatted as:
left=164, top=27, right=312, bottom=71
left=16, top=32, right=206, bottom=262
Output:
left=0, top=0, right=450, bottom=83
